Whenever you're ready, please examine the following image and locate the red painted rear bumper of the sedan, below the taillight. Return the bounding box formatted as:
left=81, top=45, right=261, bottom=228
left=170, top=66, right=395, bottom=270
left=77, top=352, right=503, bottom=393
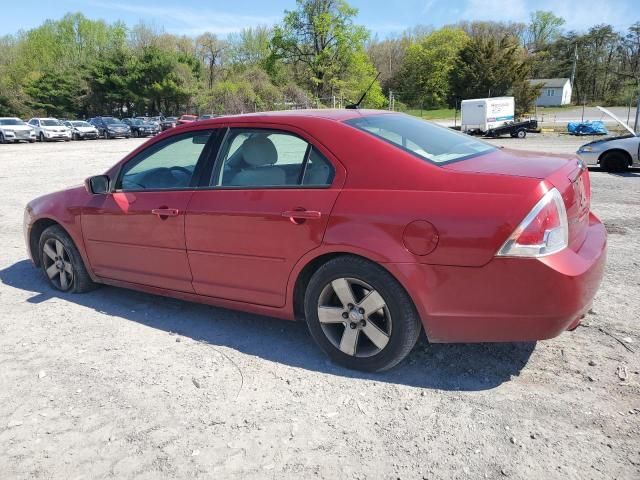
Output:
left=389, top=214, right=607, bottom=342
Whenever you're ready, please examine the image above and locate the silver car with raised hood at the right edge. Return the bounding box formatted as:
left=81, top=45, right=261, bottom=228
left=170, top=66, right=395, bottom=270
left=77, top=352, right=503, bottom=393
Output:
left=576, top=107, right=640, bottom=172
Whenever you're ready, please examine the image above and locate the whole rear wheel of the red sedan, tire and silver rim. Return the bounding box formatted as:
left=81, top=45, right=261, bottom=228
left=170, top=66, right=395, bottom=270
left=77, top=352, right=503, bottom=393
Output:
left=304, top=256, right=420, bottom=372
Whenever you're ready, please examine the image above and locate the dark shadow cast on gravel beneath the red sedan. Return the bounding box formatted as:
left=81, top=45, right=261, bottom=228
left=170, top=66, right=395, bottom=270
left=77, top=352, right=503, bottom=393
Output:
left=0, top=260, right=536, bottom=391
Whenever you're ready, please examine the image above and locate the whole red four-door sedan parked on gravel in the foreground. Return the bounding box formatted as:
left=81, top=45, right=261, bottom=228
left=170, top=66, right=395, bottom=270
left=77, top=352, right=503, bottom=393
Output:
left=24, top=110, right=606, bottom=371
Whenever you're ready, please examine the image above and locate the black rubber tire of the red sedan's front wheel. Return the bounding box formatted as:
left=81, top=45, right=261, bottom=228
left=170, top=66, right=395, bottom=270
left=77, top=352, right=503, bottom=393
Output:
left=38, top=225, right=97, bottom=293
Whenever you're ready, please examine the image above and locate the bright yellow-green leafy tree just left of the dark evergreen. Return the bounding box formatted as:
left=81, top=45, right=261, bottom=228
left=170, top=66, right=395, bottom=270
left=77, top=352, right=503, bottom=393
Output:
left=397, top=27, right=469, bottom=108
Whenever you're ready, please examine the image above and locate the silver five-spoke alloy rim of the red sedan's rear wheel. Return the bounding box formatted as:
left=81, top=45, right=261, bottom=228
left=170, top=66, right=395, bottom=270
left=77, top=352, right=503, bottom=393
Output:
left=318, top=278, right=392, bottom=357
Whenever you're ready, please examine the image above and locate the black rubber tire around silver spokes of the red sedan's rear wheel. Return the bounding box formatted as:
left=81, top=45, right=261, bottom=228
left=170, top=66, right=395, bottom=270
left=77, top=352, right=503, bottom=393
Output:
left=304, top=256, right=421, bottom=372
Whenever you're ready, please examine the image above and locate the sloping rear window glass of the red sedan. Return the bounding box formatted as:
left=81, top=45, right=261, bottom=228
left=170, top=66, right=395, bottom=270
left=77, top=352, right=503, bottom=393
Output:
left=345, top=114, right=496, bottom=164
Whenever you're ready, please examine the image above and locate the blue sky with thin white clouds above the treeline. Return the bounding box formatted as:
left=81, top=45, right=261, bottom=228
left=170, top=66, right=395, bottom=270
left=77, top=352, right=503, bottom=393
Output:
left=0, top=0, right=640, bottom=38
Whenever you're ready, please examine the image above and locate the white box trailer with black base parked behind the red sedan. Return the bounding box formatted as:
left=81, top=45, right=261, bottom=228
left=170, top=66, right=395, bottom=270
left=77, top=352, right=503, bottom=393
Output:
left=460, top=97, right=538, bottom=138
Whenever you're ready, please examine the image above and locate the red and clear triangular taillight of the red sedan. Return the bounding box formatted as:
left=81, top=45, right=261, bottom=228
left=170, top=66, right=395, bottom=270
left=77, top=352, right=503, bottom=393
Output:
left=498, top=188, right=569, bottom=257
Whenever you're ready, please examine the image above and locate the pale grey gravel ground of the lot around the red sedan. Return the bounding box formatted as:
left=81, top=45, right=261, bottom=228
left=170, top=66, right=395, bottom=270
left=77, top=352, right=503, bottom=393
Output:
left=0, top=135, right=640, bottom=479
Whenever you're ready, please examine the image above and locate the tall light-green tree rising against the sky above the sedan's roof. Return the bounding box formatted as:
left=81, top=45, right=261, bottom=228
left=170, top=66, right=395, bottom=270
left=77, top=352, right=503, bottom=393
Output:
left=271, top=0, right=368, bottom=100
